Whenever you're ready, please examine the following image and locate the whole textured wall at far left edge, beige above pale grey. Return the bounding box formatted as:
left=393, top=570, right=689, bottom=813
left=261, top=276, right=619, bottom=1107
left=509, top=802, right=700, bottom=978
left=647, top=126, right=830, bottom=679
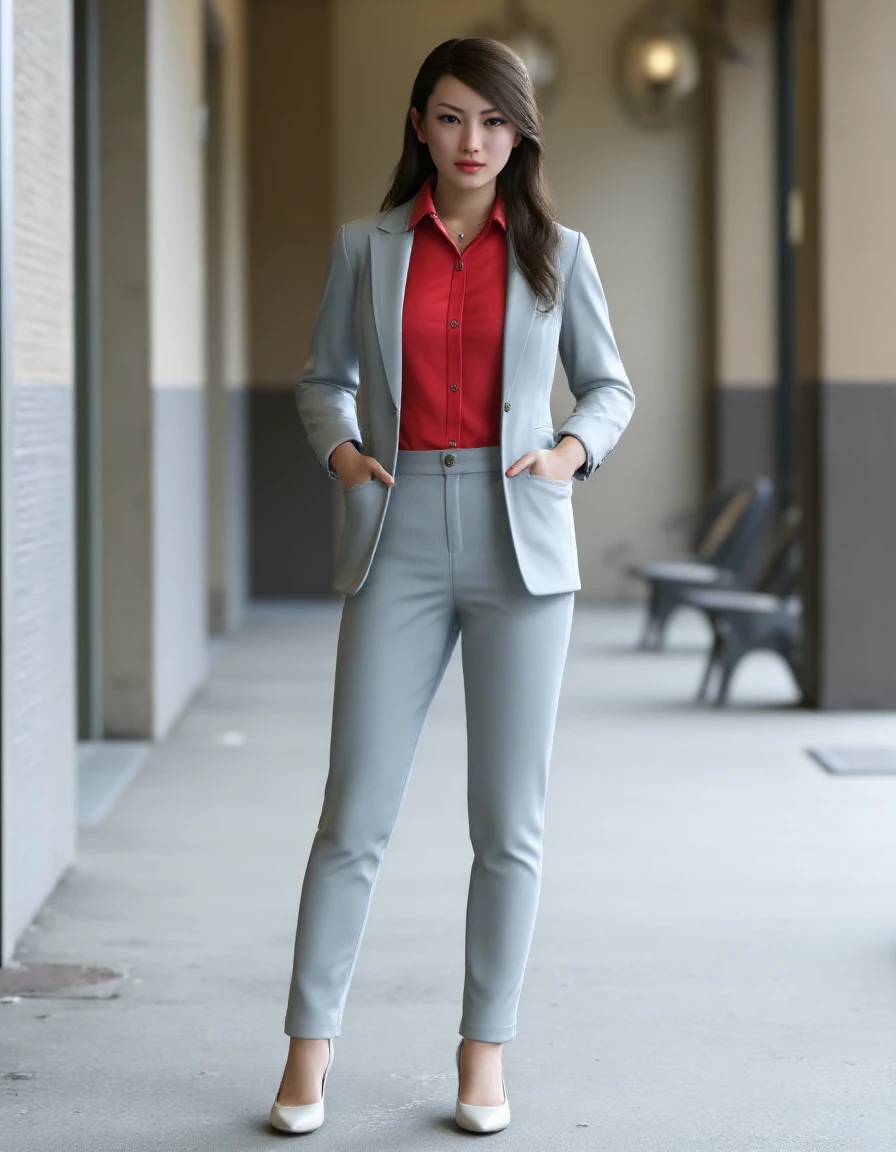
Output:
left=3, top=0, right=76, bottom=960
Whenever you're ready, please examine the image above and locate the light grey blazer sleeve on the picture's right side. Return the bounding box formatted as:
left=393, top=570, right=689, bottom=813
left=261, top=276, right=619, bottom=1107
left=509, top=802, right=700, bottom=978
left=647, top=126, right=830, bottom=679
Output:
left=555, top=233, right=635, bottom=480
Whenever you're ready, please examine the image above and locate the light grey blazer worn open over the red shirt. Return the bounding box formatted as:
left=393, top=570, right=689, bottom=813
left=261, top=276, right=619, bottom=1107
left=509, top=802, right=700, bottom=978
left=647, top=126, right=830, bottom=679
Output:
left=296, top=200, right=635, bottom=596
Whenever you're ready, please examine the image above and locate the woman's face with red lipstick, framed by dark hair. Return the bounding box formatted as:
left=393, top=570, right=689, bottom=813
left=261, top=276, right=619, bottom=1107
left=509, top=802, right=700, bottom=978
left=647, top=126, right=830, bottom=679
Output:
left=411, top=76, right=523, bottom=190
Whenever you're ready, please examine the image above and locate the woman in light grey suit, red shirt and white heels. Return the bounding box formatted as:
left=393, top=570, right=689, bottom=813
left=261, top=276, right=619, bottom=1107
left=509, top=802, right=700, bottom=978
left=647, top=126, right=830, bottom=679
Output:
left=271, top=38, right=635, bottom=1132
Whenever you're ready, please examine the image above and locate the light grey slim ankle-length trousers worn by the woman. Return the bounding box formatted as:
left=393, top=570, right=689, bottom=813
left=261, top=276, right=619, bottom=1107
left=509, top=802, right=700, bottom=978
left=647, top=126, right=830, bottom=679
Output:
left=286, top=448, right=574, bottom=1043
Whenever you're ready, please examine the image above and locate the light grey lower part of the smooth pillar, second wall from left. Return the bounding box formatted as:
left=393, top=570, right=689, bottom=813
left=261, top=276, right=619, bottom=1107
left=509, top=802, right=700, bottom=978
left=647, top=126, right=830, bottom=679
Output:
left=152, top=387, right=208, bottom=740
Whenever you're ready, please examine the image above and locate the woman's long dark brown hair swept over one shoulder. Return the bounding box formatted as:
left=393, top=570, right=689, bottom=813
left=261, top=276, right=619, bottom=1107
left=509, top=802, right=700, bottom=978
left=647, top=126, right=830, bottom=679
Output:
left=380, top=37, right=561, bottom=310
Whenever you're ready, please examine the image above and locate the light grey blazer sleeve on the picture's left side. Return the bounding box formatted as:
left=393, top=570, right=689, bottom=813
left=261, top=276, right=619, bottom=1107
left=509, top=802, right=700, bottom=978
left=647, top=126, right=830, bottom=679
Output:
left=296, top=223, right=362, bottom=479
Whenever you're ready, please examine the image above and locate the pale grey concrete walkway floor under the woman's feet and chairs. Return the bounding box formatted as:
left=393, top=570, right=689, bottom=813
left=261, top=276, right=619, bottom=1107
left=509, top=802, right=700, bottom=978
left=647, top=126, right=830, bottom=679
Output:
left=0, top=605, right=896, bottom=1152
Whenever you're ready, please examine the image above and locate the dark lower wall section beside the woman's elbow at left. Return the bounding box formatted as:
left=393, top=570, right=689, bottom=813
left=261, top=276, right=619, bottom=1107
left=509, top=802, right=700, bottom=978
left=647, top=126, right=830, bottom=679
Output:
left=249, top=387, right=335, bottom=598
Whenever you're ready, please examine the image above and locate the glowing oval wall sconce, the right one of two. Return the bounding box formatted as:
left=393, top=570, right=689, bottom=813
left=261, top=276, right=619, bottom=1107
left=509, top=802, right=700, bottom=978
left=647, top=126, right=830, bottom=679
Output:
left=616, top=2, right=700, bottom=128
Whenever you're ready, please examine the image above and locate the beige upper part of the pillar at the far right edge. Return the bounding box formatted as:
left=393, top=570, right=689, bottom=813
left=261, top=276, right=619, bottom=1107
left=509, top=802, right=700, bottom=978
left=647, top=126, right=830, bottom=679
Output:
left=819, top=0, right=896, bottom=384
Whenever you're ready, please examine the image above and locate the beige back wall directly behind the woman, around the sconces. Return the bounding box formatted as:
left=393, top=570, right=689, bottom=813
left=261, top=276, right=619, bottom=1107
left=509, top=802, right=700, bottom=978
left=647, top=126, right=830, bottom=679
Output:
left=327, top=0, right=706, bottom=598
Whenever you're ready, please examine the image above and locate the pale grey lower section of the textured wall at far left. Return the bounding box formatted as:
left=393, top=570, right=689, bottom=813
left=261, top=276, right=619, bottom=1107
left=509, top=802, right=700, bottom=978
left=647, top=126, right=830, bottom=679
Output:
left=3, top=384, right=76, bottom=939
